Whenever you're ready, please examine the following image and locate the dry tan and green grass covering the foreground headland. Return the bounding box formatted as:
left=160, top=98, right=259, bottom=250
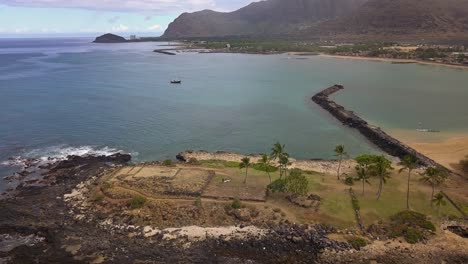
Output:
left=96, top=160, right=468, bottom=229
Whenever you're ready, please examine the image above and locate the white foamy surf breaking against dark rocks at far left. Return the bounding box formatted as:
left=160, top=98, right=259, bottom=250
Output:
left=0, top=145, right=123, bottom=168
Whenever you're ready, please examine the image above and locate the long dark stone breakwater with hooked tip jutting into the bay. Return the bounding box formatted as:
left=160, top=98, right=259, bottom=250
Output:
left=312, top=85, right=443, bottom=167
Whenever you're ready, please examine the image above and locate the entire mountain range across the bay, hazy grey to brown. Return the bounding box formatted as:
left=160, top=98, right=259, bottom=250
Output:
left=163, top=0, right=468, bottom=41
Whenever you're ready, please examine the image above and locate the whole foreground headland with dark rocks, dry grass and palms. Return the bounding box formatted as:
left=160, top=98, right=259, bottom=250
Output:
left=0, top=86, right=468, bottom=263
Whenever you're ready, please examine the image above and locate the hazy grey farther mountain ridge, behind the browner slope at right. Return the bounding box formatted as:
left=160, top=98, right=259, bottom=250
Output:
left=163, top=0, right=367, bottom=38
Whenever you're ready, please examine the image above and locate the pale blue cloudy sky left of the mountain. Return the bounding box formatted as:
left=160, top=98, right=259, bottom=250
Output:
left=0, top=0, right=253, bottom=37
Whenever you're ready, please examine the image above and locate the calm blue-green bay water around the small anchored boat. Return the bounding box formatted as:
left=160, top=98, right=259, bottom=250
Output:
left=0, top=39, right=468, bottom=191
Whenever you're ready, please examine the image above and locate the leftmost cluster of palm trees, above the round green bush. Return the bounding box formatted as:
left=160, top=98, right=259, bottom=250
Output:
left=239, top=142, right=291, bottom=184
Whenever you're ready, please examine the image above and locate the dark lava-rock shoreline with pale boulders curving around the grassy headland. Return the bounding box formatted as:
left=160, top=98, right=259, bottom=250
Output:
left=0, top=152, right=468, bottom=263
